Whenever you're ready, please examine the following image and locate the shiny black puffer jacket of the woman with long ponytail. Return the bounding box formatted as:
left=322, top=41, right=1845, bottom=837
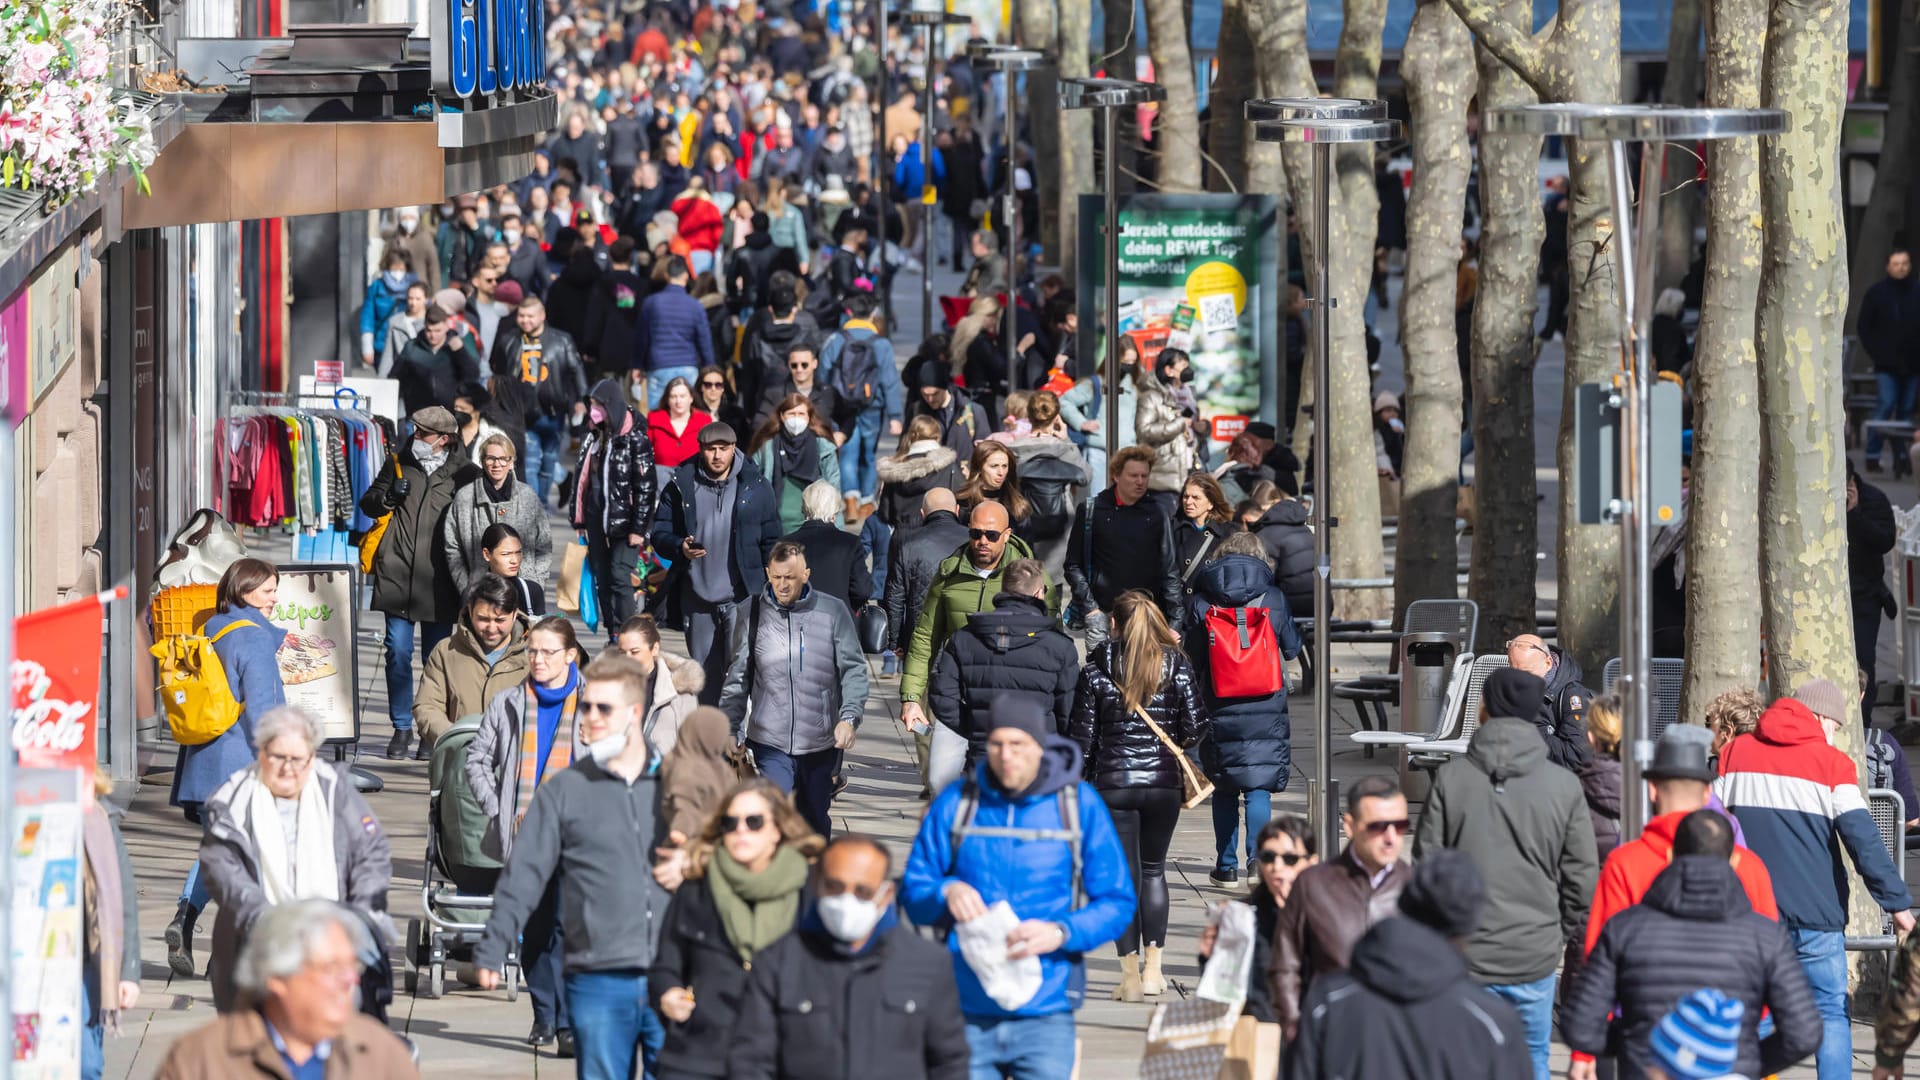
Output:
left=1068, top=642, right=1208, bottom=790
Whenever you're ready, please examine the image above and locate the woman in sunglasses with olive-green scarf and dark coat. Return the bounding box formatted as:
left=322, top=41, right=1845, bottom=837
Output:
left=647, top=778, right=826, bottom=1080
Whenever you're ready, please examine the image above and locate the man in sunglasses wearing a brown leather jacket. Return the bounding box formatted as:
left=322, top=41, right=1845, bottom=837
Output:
left=1267, top=776, right=1411, bottom=1042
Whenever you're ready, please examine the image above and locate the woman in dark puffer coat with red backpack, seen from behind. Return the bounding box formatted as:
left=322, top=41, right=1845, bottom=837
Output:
left=1187, top=532, right=1300, bottom=884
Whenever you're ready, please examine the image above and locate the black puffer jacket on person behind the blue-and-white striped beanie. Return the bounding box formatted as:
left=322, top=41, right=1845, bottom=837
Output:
left=1561, top=855, right=1820, bottom=1080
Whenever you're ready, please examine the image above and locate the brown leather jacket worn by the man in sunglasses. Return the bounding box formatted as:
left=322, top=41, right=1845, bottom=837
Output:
left=1267, top=846, right=1413, bottom=1032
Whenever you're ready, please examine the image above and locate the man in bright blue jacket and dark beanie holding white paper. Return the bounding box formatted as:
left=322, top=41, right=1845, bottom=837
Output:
left=902, top=698, right=1135, bottom=1080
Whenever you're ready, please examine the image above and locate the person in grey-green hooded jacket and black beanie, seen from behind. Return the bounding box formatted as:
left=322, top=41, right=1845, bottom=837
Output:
left=1413, top=667, right=1597, bottom=1080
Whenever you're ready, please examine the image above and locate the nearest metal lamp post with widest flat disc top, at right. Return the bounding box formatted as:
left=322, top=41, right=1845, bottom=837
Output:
left=1486, top=104, right=1788, bottom=840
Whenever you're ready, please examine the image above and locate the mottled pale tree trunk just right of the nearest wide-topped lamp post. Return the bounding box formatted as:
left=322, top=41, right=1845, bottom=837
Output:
left=1682, top=0, right=1766, bottom=724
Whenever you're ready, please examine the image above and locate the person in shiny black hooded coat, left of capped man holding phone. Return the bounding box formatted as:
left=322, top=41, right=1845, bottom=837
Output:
left=566, top=379, right=655, bottom=642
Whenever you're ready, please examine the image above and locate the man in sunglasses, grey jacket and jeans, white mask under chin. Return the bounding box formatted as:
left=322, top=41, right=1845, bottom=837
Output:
left=474, top=653, right=668, bottom=1080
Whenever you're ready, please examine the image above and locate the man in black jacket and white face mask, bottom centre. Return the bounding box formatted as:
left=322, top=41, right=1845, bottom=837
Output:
left=726, top=836, right=968, bottom=1080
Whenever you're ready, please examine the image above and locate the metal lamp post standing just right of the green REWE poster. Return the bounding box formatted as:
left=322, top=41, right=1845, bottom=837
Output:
left=1246, top=98, right=1400, bottom=851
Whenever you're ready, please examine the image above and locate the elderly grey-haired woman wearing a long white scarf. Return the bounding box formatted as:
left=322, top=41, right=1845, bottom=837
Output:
left=200, top=705, right=394, bottom=1013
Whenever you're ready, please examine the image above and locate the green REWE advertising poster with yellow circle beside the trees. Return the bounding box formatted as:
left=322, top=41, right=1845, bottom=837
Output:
left=1077, top=194, right=1281, bottom=421
